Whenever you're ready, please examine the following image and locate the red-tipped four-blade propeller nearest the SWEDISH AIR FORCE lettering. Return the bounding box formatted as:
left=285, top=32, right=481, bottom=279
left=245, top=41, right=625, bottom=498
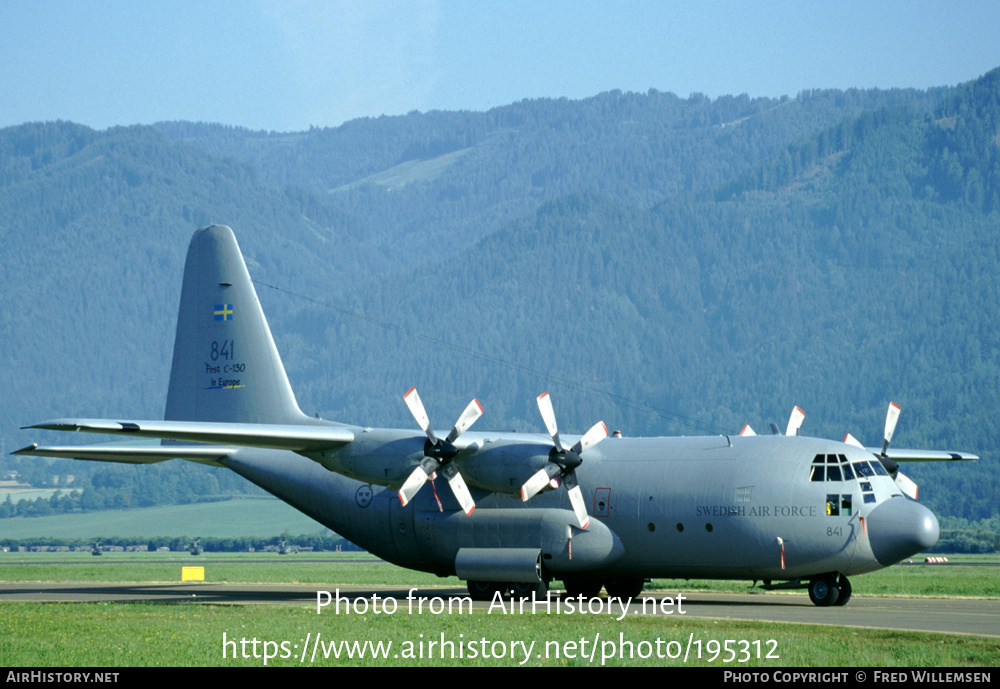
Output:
left=521, top=392, right=608, bottom=529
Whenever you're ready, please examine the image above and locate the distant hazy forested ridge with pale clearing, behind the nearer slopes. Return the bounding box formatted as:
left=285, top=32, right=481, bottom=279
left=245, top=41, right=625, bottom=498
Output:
left=157, top=89, right=945, bottom=266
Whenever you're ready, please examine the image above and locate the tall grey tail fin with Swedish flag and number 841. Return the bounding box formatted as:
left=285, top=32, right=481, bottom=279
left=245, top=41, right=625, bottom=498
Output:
left=164, top=225, right=308, bottom=424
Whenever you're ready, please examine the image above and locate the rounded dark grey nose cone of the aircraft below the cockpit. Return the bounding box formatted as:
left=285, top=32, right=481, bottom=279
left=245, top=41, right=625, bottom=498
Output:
left=867, top=497, right=941, bottom=567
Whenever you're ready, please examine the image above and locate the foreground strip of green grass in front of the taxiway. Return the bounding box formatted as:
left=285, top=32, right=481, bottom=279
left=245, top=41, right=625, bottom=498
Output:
left=0, top=603, right=1000, bottom=667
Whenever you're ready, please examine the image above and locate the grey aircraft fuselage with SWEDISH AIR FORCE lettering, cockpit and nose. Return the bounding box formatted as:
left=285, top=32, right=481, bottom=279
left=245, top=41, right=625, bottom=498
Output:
left=217, top=429, right=938, bottom=580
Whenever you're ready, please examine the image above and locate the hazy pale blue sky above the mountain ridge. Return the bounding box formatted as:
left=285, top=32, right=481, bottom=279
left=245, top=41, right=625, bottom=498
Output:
left=0, top=0, right=1000, bottom=131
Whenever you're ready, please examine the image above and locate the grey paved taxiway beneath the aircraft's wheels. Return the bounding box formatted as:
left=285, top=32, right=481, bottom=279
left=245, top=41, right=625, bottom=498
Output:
left=0, top=583, right=1000, bottom=638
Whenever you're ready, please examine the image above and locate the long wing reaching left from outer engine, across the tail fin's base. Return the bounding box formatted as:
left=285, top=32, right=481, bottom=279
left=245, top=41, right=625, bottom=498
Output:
left=24, top=419, right=354, bottom=452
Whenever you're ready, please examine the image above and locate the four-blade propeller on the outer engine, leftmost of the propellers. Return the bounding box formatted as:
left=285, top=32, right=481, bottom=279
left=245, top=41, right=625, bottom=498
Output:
left=399, top=388, right=483, bottom=514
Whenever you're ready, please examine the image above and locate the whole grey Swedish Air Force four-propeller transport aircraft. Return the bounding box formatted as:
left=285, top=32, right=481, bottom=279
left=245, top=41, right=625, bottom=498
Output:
left=15, top=225, right=976, bottom=606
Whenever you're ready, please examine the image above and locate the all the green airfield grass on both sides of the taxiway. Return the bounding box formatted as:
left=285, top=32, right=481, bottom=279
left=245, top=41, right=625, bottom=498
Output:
left=0, top=553, right=1000, bottom=667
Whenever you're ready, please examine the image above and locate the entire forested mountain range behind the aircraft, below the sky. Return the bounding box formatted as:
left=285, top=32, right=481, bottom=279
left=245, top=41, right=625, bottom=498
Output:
left=0, top=71, right=1000, bottom=519
